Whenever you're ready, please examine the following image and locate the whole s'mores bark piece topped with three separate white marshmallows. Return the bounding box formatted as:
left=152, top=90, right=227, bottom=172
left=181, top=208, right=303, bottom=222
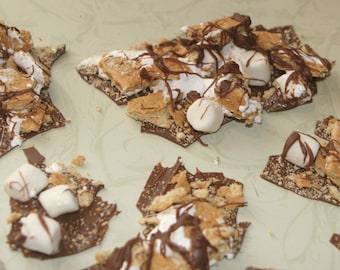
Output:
left=4, top=148, right=119, bottom=260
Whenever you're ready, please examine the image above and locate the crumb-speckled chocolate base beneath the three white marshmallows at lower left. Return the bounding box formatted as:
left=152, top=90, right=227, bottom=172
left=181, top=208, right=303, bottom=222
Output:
left=7, top=151, right=120, bottom=260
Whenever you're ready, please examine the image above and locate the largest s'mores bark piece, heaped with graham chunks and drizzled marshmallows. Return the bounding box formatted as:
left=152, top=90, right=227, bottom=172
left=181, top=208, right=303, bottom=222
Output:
left=77, top=13, right=332, bottom=147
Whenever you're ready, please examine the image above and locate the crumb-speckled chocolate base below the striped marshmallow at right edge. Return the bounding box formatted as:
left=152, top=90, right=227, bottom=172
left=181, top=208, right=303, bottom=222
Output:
left=260, top=155, right=340, bottom=206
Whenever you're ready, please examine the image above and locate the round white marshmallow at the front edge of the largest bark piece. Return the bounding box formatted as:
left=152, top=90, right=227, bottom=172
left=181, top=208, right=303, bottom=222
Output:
left=187, top=98, right=224, bottom=133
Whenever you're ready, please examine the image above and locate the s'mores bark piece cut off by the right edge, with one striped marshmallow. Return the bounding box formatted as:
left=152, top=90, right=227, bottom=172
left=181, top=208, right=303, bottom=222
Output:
left=261, top=116, right=340, bottom=206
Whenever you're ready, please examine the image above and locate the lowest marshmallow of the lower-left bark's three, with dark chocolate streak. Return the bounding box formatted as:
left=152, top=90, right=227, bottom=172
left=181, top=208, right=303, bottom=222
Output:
left=20, top=213, right=62, bottom=255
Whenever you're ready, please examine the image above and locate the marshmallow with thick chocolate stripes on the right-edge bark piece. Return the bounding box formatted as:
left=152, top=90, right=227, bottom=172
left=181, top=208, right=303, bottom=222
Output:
left=282, top=131, right=320, bottom=168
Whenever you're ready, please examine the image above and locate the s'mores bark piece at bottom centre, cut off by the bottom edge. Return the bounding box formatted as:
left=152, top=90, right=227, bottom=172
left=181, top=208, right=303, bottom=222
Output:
left=88, top=159, right=250, bottom=269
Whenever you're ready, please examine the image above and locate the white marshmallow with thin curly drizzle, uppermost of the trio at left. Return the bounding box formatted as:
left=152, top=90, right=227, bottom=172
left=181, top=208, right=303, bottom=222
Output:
left=4, top=163, right=48, bottom=202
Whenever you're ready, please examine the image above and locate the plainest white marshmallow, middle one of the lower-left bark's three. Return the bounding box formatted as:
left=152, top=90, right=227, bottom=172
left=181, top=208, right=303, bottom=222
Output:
left=38, top=185, right=79, bottom=218
